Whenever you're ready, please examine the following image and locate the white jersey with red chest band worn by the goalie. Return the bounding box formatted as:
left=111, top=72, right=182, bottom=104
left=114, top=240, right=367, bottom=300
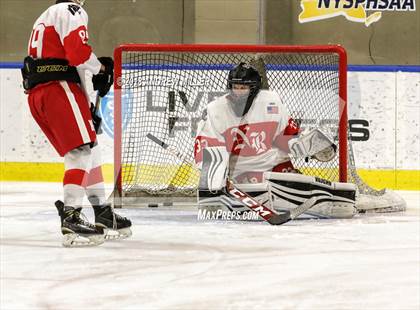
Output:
left=194, top=90, right=299, bottom=178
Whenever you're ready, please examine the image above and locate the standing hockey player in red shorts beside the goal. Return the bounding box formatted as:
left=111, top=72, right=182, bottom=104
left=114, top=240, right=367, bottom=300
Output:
left=22, top=0, right=131, bottom=246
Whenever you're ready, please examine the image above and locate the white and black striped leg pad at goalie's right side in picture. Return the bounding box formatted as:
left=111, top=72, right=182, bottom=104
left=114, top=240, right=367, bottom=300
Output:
left=264, top=172, right=356, bottom=218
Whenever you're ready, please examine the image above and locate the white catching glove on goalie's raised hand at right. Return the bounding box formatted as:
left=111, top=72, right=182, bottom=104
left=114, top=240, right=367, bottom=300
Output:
left=288, top=128, right=337, bottom=162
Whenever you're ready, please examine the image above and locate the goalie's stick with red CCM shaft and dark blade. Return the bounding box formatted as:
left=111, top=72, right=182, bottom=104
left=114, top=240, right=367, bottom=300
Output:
left=146, top=133, right=316, bottom=225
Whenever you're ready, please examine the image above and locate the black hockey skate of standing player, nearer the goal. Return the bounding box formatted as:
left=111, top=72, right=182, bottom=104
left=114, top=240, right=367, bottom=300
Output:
left=88, top=196, right=132, bottom=240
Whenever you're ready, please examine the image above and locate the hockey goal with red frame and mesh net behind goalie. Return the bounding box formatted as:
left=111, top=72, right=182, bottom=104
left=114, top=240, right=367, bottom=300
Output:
left=114, top=44, right=355, bottom=202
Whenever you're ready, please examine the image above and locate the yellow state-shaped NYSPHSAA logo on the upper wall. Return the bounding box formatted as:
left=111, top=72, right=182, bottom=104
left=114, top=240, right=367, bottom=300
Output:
left=299, top=0, right=416, bottom=27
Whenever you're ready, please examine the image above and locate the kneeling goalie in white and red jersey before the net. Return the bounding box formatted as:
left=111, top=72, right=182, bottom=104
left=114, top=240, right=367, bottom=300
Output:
left=194, top=63, right=356, bottom=218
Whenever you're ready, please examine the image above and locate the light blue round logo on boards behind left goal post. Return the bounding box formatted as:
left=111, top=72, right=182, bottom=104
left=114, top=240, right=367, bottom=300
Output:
left=99, top=89, right=133, bottom=138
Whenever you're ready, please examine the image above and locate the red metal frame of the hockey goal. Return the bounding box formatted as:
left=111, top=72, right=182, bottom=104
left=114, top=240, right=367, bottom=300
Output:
left=114, top=44, right=348, bottom=199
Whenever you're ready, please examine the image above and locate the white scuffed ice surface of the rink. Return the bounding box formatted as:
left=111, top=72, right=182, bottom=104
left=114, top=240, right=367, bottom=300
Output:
left=0, top=183, right=420, bottom=310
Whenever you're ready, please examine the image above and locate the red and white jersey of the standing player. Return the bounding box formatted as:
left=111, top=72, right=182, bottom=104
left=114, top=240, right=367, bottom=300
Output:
left=28, top=2, right=101, bottom=78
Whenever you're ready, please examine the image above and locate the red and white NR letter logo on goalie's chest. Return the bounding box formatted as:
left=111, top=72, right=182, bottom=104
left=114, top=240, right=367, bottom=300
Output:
left=230, top=126, right=267, bottom=154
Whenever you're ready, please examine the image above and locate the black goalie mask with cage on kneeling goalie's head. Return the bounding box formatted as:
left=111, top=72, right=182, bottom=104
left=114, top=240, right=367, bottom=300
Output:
left=227, top=62, right=261, bottom=117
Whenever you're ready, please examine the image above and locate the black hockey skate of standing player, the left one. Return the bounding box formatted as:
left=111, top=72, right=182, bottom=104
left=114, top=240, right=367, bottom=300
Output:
left=55, top=200, right=104, bottom=247
